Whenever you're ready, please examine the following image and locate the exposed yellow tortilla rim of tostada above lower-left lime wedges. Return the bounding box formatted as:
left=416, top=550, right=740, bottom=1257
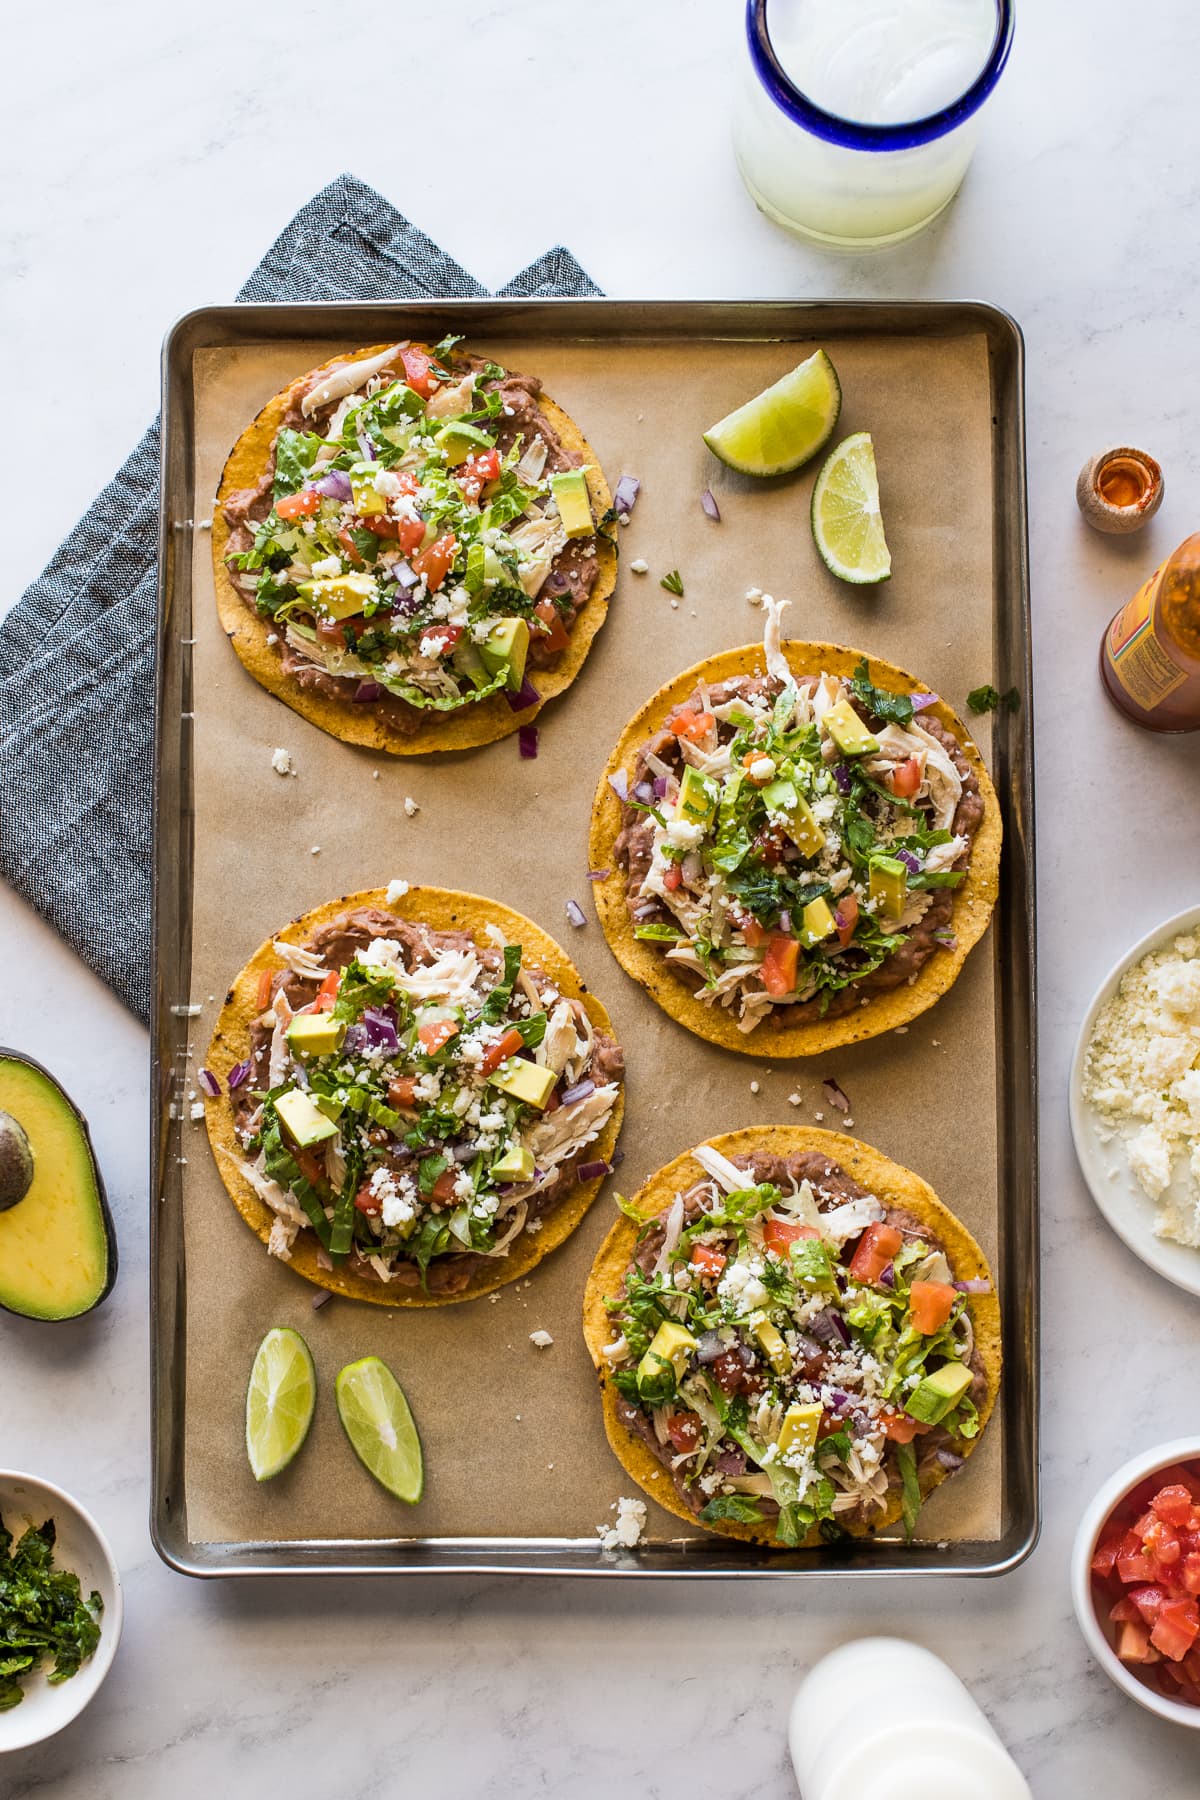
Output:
left=205, top=887, right=624, bottom=1307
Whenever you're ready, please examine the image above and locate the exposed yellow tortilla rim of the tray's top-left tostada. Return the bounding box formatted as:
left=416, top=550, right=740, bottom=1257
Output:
left=212, top=344, right=617, bottom=756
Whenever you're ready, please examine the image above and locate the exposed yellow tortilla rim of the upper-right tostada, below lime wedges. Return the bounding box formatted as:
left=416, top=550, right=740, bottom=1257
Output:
left=588, top=639, right=1004, bottom=1058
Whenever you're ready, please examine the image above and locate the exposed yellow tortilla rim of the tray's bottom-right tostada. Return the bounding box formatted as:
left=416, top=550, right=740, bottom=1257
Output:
left=583, top=1125, right=1002, bottom=1550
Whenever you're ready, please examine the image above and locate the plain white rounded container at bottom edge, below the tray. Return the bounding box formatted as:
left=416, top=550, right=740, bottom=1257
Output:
left=788, top=1638, right=1031, bottom=1800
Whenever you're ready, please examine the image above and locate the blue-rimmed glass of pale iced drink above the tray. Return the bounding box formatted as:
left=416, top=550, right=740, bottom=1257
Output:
left=734, top=0, right=1013, bottom=248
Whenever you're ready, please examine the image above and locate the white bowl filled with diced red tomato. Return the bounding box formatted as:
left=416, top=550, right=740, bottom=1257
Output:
left=1070, top=1438, right=1200, bottom=1730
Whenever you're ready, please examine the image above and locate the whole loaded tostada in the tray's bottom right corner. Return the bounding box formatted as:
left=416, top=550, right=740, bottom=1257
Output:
left=583, top=1125, right=1000, bottom=1548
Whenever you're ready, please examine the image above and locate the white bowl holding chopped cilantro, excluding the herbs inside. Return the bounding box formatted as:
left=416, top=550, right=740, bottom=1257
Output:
left=0, top=1469, right=124, bottom=1753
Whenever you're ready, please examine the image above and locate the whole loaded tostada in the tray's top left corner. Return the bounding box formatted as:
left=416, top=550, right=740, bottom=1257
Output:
left=212, top=337, right=617, bottom=756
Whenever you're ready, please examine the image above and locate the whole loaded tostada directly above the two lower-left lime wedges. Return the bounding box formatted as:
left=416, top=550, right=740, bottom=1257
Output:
left=201, top=882, right=624, bottom=1307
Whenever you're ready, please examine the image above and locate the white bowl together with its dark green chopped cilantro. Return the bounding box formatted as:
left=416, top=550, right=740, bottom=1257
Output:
left=0, top=1469, right=122, bottom=1753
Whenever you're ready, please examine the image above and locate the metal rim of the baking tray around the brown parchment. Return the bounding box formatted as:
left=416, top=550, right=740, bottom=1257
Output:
left=149, top=299, right=1040, bottom=1577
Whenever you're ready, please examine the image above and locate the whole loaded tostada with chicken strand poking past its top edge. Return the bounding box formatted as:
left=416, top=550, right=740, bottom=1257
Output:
left=590, top=599, right=1002, bottom=1057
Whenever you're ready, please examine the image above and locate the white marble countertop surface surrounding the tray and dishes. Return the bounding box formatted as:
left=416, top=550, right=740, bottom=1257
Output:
left=0, top=0, right=1200, bottom=1800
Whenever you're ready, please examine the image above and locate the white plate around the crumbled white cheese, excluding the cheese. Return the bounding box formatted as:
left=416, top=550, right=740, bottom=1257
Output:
left=1070, top=905, right=1200, bottom=1294
